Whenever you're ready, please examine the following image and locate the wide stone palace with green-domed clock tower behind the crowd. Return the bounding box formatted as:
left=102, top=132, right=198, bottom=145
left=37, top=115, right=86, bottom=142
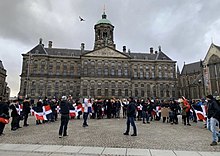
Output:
left=19, top=12, right=177, bottom=99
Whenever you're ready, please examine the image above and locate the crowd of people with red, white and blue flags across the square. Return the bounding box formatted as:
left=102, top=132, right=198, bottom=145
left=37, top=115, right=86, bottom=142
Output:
left=0, top=95, right=220, bottom=146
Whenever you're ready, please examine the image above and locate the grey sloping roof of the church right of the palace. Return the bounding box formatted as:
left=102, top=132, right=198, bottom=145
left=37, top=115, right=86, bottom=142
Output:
left=181, top=61, right=201, bottom=75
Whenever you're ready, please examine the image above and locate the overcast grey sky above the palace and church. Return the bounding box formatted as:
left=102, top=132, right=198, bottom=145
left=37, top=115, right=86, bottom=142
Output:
left=0, top=0, right=220, bottom=96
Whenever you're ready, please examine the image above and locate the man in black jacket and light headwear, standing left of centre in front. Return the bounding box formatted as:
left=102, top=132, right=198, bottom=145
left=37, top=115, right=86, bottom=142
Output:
left=59, top=96, right=70, bottom=138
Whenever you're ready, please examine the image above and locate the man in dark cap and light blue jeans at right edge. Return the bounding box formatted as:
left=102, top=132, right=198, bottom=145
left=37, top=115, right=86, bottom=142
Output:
left=206, top=95, right=220, bottom=146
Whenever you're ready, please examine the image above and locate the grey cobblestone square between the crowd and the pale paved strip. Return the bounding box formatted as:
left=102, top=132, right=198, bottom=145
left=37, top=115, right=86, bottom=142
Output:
left=0, top=116, right=220, bottom=151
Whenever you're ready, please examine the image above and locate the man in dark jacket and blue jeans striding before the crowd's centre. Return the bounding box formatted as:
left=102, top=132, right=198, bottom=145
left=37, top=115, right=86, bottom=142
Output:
left=124, top=97, right=137, bottom=136
